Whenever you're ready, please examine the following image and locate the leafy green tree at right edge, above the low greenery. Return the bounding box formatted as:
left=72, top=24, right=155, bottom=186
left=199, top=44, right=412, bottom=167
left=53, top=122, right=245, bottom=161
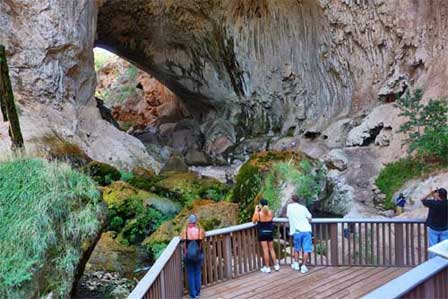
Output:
left=397, top=89, right=448, bottom=162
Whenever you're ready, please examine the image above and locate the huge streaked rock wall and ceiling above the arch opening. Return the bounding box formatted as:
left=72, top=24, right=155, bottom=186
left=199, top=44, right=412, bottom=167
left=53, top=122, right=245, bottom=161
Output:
left=97, top=0, right=448, bottom=136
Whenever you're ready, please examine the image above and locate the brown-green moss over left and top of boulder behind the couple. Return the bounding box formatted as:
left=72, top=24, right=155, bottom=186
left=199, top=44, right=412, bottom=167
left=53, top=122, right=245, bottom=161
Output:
left=230, top=151, right=322, bottom=222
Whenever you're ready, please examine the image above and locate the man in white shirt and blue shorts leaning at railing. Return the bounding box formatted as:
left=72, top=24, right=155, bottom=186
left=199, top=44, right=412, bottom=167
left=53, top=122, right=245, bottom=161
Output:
left=286, top=195, right=313, bottom=273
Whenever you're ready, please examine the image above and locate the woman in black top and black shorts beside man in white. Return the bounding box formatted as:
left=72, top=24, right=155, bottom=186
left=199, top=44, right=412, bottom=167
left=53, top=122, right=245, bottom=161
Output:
left=252, top=198, right=280, bottom=273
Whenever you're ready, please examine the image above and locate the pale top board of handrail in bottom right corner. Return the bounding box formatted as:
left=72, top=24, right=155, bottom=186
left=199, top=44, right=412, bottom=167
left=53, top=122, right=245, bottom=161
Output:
left=362, top=257, right=448, bottom=299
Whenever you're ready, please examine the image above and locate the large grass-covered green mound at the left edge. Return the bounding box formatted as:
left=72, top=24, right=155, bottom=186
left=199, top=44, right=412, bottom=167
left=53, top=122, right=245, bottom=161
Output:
left=0, top=158, right=104, bottom=299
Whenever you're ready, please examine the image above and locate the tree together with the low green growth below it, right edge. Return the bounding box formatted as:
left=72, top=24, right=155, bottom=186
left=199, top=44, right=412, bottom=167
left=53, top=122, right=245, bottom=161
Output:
left=375, top=89, right=448, bottom=209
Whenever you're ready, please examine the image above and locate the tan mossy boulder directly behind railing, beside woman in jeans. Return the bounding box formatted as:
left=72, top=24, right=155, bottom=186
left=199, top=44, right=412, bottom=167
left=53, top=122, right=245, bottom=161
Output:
left=143, top=199, right=239, bottom=250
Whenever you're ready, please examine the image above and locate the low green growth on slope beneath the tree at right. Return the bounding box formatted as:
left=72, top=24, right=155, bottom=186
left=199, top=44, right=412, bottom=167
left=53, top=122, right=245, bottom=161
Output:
left=375, top=157, right=448, bottom=209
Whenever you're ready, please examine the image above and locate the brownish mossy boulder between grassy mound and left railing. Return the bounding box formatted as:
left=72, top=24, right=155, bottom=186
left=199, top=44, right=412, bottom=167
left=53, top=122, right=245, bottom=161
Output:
left=86, top=232, right=145, bottom=278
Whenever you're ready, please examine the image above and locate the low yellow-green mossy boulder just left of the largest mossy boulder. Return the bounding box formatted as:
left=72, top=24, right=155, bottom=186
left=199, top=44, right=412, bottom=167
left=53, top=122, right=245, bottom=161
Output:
left=154, top=171, right=229, bottom=205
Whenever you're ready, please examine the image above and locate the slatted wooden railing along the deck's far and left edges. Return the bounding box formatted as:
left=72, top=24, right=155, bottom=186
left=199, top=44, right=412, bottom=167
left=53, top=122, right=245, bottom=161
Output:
left=128, top=218, right=427, bottom=299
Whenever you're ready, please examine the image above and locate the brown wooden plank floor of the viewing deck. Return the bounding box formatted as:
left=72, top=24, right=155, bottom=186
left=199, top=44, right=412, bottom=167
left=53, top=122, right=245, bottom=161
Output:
left=191, top=266, right=410, bottom=299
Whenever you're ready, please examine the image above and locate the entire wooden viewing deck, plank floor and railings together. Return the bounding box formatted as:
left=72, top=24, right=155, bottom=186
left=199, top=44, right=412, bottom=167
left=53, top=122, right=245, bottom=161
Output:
left=128, top=219, right=448, bottom=299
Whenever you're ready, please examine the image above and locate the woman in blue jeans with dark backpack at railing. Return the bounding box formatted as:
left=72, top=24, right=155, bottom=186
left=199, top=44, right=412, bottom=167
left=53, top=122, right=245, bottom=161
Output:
left=181, top=215, right=205, bottom=299
